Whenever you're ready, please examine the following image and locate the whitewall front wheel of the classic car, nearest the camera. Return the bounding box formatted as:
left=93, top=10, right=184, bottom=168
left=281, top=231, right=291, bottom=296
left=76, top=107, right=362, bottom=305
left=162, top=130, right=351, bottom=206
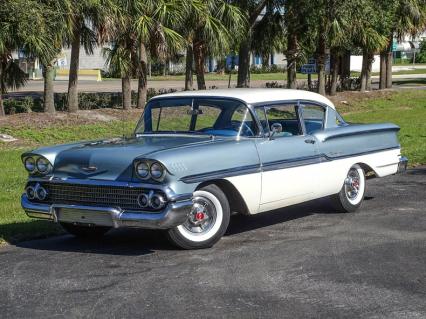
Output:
left=167, top=184, right=230, bottom=249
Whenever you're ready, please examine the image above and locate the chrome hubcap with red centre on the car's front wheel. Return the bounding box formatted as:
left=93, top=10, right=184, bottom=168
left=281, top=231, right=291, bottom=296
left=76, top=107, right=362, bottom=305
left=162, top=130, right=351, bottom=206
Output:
left=183, top=196, right=216, bottom=234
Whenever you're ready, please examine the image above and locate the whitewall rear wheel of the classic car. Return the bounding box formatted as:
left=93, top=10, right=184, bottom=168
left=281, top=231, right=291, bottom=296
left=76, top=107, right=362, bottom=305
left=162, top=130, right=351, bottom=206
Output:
left=334, top=164, right=365, bottom=213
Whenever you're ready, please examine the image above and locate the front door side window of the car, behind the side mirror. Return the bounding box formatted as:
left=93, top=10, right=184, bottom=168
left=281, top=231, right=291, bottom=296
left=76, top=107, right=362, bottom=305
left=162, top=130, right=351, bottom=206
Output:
left=265, top=104, right=302, bottom=137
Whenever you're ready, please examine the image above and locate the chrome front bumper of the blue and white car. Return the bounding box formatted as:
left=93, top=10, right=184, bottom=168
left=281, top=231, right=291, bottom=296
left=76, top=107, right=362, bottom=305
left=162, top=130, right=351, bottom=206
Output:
left=21, top=194, right=192, bottom=229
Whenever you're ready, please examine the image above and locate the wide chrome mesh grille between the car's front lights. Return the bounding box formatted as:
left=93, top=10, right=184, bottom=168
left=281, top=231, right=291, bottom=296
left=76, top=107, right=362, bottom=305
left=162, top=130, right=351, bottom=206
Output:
left=36, top=183, right=164, bottom=210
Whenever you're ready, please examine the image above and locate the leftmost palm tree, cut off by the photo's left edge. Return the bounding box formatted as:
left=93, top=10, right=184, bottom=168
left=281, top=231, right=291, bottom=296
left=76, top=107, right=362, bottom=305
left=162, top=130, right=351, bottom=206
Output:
left=0, top=0, right=53, bottom=116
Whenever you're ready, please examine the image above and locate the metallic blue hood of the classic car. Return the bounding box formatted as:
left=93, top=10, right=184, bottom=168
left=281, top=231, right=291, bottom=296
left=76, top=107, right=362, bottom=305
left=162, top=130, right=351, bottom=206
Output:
left=49, top=136, right=214, bottom=181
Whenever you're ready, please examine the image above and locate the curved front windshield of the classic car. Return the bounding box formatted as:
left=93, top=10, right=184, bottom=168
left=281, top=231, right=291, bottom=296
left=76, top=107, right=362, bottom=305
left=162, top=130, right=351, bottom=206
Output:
left=135, top=99, right=258, bottom=137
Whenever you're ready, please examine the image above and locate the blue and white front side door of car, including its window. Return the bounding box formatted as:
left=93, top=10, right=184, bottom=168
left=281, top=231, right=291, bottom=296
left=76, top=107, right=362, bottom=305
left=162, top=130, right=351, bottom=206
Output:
left=256, top=103, right=320, bottom=211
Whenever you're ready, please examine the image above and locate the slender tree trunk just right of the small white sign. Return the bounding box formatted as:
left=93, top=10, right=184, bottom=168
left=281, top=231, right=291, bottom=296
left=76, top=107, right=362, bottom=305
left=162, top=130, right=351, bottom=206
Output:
left=68, top=24, right=81, bottom=113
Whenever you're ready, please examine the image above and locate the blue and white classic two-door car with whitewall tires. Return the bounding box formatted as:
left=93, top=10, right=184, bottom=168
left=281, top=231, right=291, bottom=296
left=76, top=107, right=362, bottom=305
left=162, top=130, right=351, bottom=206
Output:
left=22, top=89, right=407, bottom=249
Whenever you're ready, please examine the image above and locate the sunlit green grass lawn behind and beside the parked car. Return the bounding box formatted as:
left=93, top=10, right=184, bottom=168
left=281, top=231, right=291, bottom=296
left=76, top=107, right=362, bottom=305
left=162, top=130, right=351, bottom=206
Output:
left=0, top=90, right=426, bottom=243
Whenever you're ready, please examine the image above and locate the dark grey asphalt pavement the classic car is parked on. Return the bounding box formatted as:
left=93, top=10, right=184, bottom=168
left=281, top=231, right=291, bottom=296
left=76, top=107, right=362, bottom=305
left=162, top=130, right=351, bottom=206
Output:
left=0, top=167, right=426, bottom=319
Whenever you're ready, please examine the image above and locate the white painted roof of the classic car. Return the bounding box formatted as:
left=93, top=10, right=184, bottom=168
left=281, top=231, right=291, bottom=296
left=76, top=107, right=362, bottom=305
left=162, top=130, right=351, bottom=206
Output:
left=152, top=88, right=335, bottom=109
